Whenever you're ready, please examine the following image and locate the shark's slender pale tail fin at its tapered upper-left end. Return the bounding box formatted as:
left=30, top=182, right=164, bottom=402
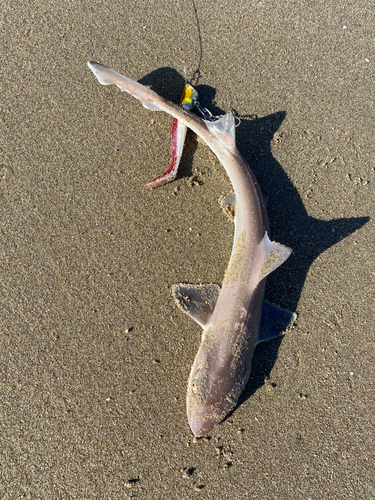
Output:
left=87, top=62, right=164, bottom=110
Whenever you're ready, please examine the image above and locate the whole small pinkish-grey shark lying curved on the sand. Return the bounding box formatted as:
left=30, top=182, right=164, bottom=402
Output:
left=88, top=62, right=295, bottom=437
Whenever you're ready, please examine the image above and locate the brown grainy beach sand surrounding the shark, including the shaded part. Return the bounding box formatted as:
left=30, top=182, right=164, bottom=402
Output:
left=0, top=0, right=375, bottom=500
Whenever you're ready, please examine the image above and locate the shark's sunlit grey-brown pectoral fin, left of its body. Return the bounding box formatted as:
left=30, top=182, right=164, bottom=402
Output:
left=172, top=283, right=220, bottom=328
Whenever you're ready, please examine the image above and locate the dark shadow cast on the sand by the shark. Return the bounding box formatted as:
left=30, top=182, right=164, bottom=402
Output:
left=140, top=68, right=370, bottom=419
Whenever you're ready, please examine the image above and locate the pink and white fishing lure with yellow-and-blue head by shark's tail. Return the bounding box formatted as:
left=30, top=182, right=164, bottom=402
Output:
left=146, top=84, right=198, bottom=188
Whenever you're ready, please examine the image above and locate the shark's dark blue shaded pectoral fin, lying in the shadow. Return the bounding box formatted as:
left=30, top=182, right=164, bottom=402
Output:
left=257, top=301, right=297, bottom=344
